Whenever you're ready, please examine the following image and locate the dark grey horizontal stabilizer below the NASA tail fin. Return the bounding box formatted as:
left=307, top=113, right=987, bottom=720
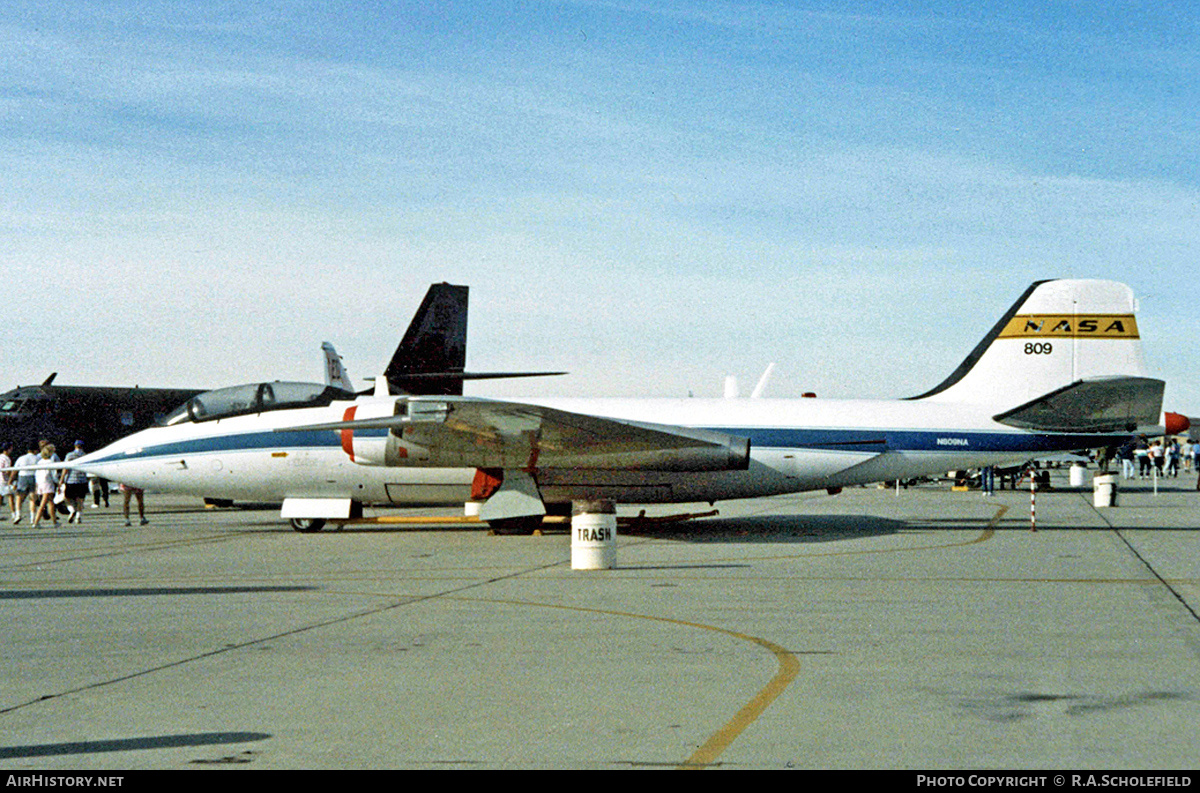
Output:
left=994, top=377, right=1166, bottom=433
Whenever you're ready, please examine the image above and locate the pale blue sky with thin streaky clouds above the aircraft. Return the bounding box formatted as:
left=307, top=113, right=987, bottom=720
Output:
left=0, top=0, right=1200, bottom=415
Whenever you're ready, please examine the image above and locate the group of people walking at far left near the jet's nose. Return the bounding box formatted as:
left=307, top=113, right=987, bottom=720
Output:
left=0, top=440, right=149, bottom=528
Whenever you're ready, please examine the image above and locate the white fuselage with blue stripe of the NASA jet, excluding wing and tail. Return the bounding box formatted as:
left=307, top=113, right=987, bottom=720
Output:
left=79, top=397, right=1116, bottom=504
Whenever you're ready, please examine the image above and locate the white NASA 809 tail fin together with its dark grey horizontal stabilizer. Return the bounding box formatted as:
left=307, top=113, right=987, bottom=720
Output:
left=911, top=280, right=1162, bottom=419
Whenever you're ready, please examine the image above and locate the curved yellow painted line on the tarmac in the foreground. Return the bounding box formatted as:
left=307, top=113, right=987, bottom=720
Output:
left=457, top=597, right=800, bottom=769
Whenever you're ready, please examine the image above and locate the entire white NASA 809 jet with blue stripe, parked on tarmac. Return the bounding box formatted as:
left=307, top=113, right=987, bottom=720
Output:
left=54, top=280, right=1164, bottom=530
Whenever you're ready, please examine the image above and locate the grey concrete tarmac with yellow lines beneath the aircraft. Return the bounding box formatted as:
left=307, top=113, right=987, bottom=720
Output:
left=0, top=473, right=1200, bottom=770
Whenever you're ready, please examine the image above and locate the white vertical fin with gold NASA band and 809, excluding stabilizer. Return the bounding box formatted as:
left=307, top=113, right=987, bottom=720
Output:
left=913, top=278, right=1157, bottom=413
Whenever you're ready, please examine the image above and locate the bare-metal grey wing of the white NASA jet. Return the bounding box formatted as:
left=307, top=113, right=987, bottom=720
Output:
left=284, top=396, right=750, bottom=471
